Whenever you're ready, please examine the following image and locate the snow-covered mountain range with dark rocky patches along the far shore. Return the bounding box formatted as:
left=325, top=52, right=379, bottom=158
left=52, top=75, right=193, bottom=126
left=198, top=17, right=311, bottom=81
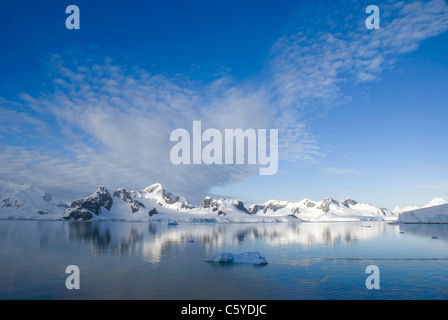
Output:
left=0, top=180, right=444, bottom=222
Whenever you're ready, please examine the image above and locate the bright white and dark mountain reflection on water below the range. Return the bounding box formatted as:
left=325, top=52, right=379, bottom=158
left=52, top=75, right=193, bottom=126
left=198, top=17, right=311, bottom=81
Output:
left=65, top=222, right=387, bottom=262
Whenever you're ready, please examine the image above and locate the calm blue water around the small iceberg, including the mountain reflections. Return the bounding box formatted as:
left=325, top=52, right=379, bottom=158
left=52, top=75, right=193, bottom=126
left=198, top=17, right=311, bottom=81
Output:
left=0, top=221, right=448, bottom=300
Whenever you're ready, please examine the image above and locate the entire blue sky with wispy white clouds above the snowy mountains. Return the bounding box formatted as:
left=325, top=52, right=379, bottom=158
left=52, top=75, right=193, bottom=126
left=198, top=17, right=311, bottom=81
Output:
left=0, top=0, right=448, bottom=209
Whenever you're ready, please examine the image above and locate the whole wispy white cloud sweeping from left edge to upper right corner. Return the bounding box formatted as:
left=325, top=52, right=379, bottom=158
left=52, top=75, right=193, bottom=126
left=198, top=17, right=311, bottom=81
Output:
left=0, top=0, right=448, bottom=201
